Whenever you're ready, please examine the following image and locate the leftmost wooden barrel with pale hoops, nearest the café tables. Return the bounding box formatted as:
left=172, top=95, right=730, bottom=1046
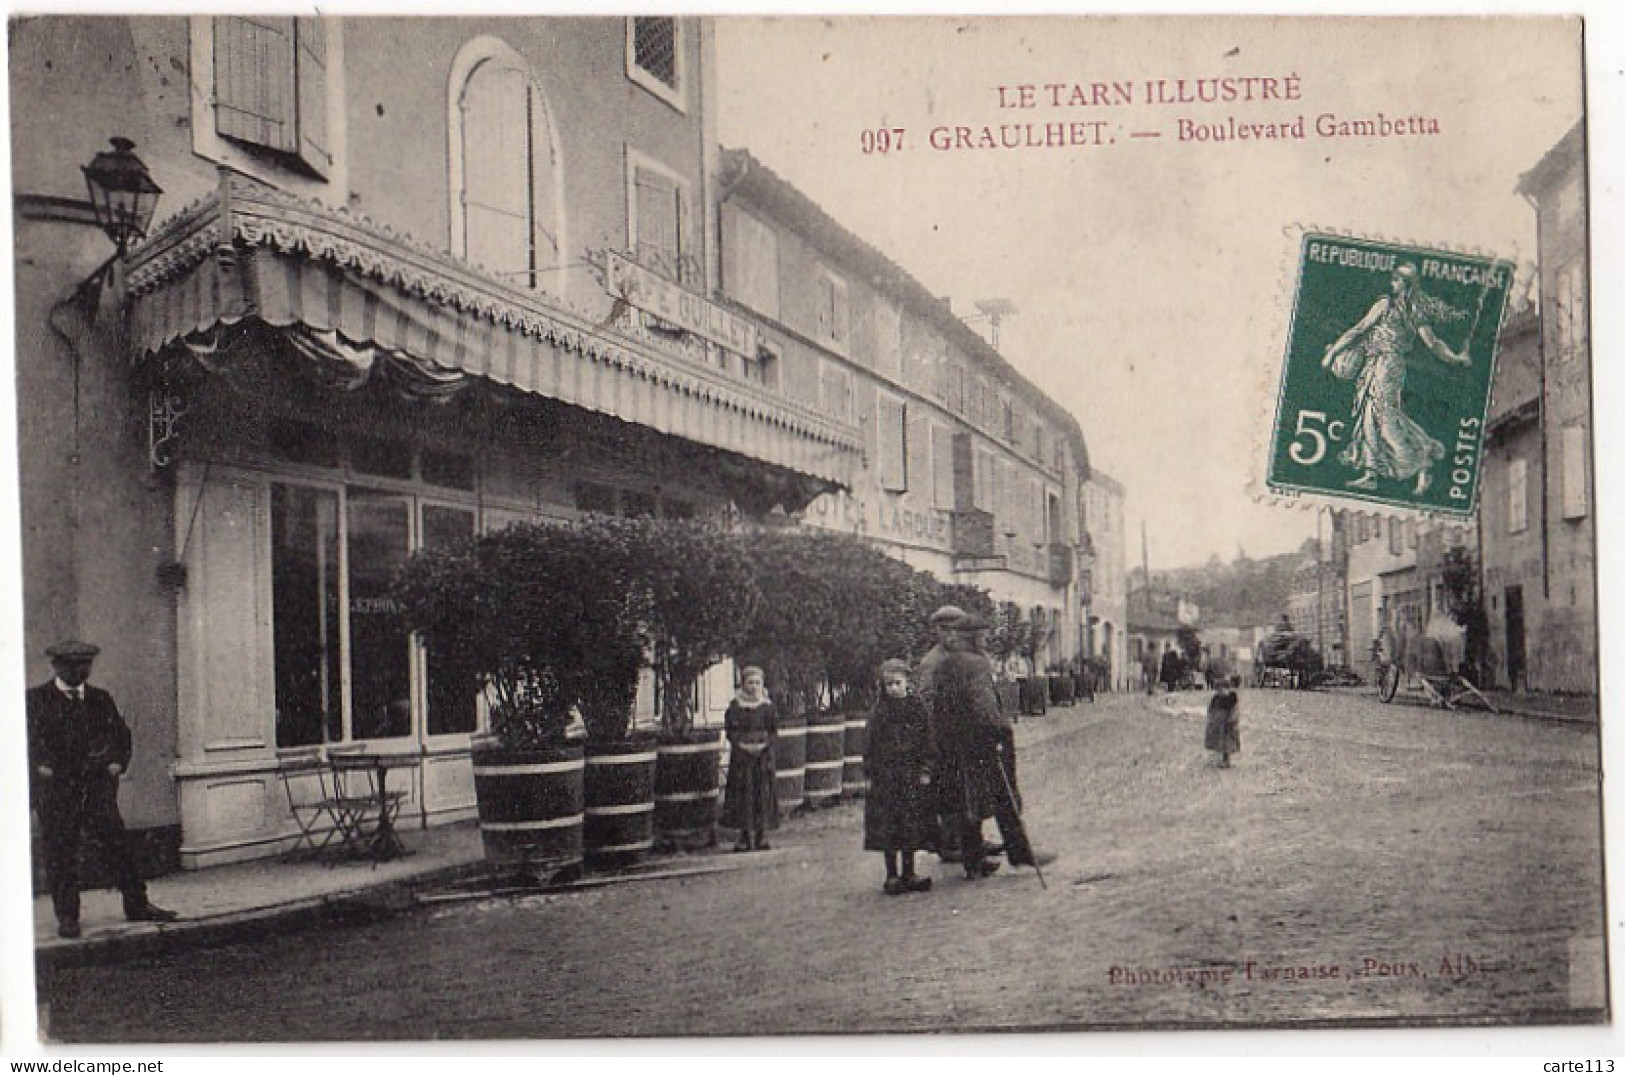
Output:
left=471, top=742, right=585, bottom=877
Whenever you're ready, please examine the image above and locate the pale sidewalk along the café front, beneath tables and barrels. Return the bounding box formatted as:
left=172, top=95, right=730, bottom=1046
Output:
left=34, top=822, right=780, bottom=969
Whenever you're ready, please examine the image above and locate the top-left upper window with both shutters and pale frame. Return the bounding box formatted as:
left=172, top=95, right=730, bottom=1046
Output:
left=204, top=15, right=341, bottom=182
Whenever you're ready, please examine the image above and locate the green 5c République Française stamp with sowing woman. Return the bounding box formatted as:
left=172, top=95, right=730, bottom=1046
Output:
left=1268, top=232, right=1513, bottom=516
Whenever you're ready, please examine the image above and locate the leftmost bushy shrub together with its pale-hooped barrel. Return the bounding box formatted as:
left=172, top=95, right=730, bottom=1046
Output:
left=395, top=523, right=635, bottom=880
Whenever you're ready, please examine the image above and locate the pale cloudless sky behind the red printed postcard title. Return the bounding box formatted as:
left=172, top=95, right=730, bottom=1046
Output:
left=717, top=16, right=1581, bottom=570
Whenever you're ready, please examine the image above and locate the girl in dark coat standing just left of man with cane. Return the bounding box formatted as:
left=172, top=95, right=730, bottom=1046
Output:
left=863, top=659, right=936, bottom=896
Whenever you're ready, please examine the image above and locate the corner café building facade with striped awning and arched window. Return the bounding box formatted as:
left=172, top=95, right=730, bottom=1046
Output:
left=10, top=16, right=865, bottom=867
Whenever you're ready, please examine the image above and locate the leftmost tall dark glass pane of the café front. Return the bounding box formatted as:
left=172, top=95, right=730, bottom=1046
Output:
left=271, top=482, right=345, bottom=747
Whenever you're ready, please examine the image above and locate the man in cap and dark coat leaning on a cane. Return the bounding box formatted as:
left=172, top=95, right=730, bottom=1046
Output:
left=933, top=615, right=1053, bottom=877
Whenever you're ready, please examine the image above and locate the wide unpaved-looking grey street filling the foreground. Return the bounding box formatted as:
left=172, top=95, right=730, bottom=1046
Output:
left=41, top=690, right=1604, bottom=1041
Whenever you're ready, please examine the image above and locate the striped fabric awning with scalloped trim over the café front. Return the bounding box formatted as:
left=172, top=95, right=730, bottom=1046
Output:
left=125, top=175, right=861, bottom=487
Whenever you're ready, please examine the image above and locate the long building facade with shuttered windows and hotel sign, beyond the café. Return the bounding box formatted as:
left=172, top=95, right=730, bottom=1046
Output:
left=718, top=149, right=1089, bottom=671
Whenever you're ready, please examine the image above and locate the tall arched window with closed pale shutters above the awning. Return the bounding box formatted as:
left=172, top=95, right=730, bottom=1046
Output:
left=449, top=37, right=566, bottom=291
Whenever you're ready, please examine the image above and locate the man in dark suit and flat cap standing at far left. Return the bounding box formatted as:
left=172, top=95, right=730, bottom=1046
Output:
left=26, top=640, right=177, bottom=937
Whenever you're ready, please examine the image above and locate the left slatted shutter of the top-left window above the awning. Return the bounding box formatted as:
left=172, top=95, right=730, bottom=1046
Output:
left=215, top=15, right=299, bottom=153
